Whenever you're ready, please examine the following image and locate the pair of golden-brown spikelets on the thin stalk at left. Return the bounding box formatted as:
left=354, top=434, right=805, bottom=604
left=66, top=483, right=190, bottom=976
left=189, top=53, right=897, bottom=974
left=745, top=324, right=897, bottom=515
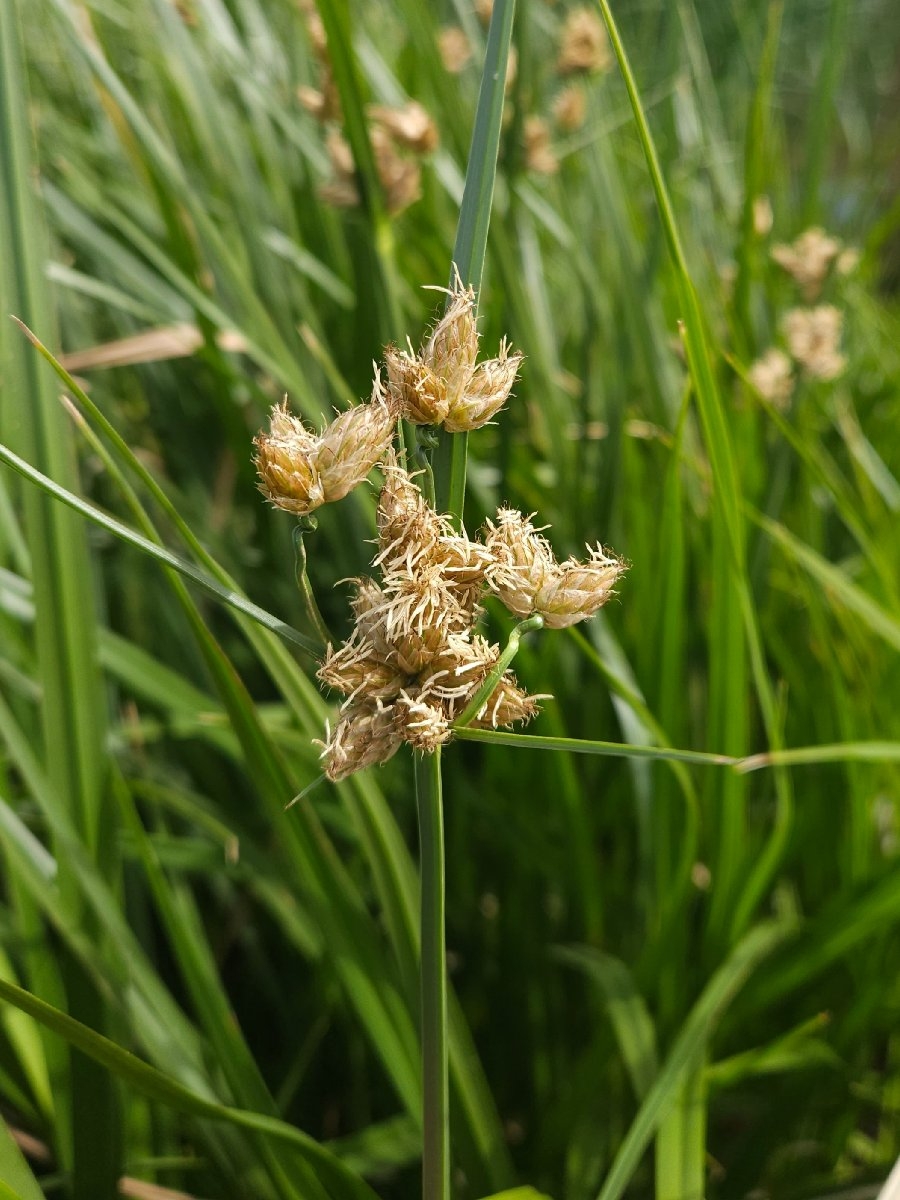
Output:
left=253, top=374, right=397, bottom=516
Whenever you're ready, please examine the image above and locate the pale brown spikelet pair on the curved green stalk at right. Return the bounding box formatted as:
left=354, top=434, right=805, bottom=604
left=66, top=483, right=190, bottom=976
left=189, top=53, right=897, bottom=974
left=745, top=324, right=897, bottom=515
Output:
left=485, top=509, right=625, bottom=629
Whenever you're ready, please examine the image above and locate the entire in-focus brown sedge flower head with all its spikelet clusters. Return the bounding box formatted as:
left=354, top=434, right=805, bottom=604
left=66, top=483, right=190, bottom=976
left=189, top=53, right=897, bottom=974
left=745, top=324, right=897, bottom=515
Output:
left=254, top=275, right=624, bottom=780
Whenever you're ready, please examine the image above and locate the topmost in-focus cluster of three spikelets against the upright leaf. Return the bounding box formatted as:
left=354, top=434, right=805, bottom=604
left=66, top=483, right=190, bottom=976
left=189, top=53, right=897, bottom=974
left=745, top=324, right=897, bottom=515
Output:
left=384, top=275, right=522, bottom=433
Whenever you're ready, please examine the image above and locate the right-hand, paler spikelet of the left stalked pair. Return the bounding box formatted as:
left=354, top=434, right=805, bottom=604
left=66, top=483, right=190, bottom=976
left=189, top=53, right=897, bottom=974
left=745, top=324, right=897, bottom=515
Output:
left=316, top=376, right=396, bottom=500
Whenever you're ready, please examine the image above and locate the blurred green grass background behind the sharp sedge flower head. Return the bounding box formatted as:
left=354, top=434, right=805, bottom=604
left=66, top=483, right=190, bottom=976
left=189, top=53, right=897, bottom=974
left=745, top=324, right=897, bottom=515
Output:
left=0, top=0, right=900, bottom=1200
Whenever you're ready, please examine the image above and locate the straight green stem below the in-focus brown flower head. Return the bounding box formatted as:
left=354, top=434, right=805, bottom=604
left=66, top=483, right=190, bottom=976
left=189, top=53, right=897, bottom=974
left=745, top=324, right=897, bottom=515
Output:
left=415, top=749, right=450, bottom=1200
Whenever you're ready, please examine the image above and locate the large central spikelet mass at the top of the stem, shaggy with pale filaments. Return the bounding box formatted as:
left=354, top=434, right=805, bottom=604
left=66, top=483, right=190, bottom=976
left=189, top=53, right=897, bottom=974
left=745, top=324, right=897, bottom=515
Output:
left=319, top=462, right=538, bottom=780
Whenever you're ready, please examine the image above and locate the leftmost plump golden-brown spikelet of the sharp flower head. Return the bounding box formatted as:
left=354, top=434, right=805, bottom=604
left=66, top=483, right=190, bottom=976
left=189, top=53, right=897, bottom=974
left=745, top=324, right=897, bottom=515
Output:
left=253, top=401, right=326, bottom=516
